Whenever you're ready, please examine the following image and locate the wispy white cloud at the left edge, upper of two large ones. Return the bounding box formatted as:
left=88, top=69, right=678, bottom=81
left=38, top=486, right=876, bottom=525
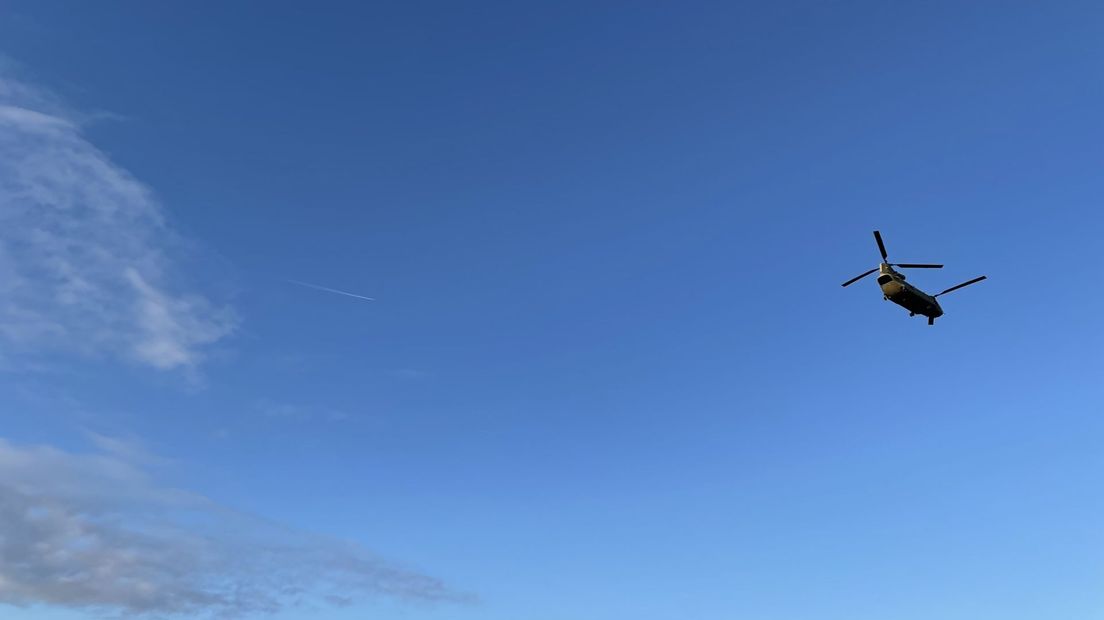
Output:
left=0, top=73, right=237, bottom=370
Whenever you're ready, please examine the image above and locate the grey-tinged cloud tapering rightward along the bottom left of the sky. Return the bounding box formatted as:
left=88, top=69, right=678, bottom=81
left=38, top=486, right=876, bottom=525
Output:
left=0, top=437, right=464, bottom=618
